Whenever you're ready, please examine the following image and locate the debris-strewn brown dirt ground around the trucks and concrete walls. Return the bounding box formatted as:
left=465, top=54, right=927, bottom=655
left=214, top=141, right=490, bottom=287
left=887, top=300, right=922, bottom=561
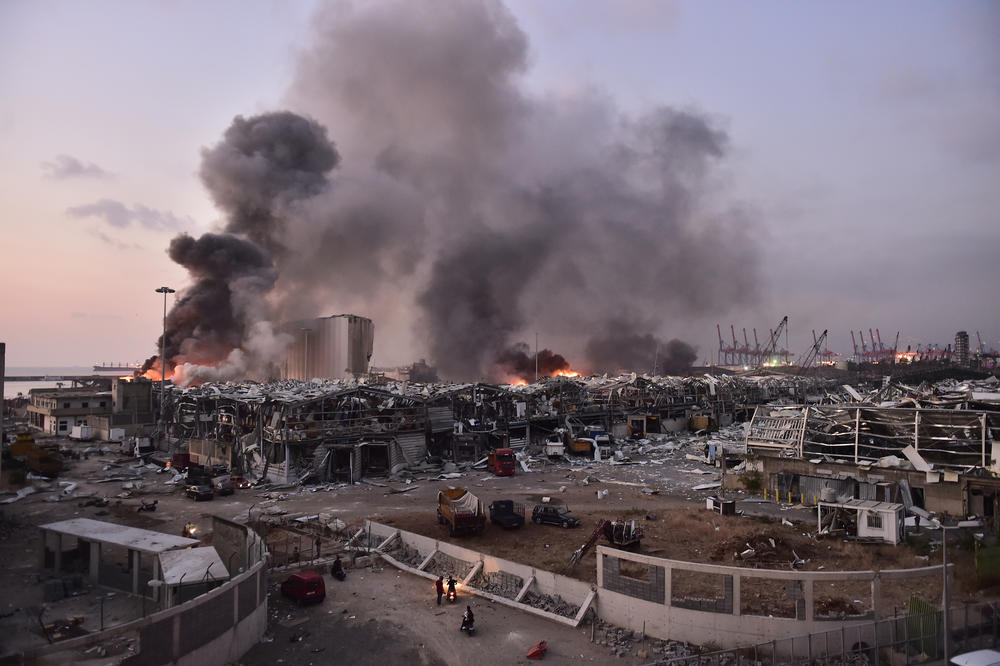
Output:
left=0, top=430, right=988, bottom=663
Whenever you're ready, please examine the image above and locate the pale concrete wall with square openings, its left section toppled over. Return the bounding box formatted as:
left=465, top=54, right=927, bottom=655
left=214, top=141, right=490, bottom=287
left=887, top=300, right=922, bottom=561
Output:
left=368, top=522, right=941, bottom=656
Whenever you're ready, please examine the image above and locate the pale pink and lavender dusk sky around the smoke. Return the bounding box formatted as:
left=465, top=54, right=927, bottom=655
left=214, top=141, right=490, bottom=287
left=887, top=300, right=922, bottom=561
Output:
left=0, top=0, right=1000, bottom=366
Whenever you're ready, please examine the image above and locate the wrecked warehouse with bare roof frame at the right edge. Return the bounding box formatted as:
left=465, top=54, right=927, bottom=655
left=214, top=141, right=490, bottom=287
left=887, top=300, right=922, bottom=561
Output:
left=746, top=396, right=1000, bottom=525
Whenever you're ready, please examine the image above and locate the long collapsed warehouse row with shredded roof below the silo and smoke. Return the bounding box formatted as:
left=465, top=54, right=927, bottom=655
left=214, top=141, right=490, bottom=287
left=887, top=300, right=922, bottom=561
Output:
left=155, top=375, right=836, bottom=483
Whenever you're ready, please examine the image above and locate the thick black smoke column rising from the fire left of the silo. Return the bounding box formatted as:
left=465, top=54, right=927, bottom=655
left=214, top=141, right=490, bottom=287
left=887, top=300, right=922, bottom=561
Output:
left=144, top=112, right=339, bottom=381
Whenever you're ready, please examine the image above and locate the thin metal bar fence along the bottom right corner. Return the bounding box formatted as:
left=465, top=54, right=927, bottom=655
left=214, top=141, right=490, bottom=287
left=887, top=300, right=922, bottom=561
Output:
left=647, top=603, right=1000, bottom=666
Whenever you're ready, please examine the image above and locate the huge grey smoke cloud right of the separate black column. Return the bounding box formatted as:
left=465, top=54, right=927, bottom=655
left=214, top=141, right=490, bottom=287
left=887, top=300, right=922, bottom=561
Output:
left=278, top=0, right=757, bottom=379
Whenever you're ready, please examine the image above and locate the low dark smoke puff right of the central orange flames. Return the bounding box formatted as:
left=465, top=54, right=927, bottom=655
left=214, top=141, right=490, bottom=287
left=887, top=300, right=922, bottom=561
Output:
left=586, top=331, right=698, bottom=375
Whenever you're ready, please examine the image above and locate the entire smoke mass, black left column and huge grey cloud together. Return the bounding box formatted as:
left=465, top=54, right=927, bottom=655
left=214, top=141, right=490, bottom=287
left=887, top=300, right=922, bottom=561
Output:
left=150, top=0, right=758, bottom=380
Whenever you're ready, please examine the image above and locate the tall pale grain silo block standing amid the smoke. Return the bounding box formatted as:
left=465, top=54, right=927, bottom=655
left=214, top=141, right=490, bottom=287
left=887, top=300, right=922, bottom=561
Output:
left=281, top=315, right=375, bottom=380
